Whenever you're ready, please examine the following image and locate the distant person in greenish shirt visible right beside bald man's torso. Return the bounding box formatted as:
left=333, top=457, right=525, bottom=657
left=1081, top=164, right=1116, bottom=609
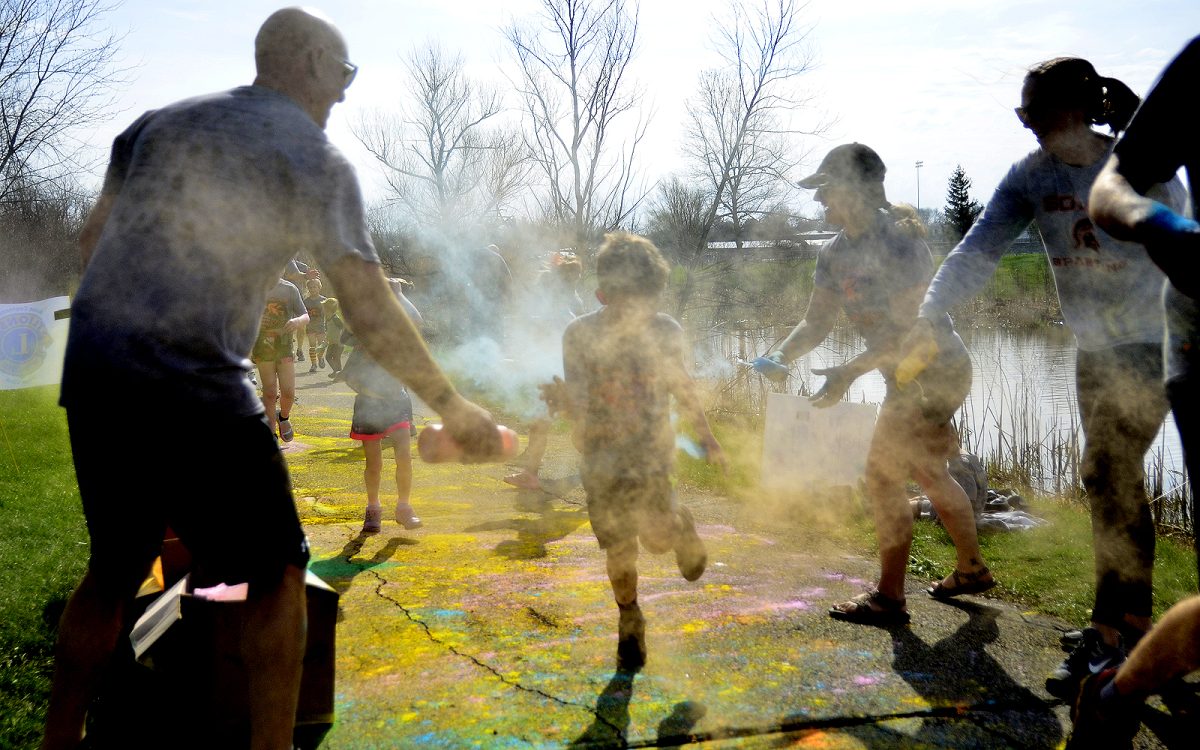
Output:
left=250, top=278, right=308, bottom=443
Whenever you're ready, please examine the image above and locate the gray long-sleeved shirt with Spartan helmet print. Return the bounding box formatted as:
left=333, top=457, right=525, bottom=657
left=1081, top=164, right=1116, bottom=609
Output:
left=920, top=149, right=1186, bottom=352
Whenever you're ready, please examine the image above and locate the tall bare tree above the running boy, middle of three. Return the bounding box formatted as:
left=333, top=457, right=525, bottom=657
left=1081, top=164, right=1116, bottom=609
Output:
left=506, top=0, right=648, bottom=247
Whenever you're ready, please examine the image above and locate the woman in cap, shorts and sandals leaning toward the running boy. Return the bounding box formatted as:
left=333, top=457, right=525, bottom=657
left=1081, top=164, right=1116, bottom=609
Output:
left=760, top=143, right=996, bottom=625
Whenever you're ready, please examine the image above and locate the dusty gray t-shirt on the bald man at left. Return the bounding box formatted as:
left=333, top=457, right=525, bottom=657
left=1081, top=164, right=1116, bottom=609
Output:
left=60, top=86, right=378, bottom=415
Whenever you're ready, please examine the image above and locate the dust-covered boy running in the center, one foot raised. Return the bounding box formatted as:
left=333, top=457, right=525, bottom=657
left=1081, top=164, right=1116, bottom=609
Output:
left=542, top=233, right=725, bottom=670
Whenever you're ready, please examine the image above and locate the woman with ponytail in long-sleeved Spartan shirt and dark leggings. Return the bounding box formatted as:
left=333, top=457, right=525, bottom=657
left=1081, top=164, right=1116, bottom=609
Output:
left=910, top=58, right=1184, bottom=698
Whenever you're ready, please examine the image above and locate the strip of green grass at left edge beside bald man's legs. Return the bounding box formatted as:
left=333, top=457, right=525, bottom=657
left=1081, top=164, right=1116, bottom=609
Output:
left=0, top=386, right=88, bottom=748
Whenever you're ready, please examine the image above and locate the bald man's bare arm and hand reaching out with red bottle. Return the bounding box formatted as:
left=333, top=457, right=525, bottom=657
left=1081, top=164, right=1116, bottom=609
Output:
left=325, top=256, right=500, bottom=456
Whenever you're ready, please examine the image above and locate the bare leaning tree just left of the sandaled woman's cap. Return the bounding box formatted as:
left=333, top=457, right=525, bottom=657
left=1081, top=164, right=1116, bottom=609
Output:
left=684, top=0, right=821, bottom=253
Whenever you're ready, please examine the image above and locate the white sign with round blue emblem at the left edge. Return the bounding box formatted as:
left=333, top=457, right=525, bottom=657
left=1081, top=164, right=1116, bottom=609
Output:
left=0, top=296, right=71, bottom=390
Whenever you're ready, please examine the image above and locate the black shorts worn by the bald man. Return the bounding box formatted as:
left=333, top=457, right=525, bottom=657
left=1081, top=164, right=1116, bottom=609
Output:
left=67, top=408, right=308, bottom=586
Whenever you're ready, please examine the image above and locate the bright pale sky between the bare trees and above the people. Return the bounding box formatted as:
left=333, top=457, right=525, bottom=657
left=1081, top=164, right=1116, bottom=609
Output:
left=85, top=0, right=1200, bottom=215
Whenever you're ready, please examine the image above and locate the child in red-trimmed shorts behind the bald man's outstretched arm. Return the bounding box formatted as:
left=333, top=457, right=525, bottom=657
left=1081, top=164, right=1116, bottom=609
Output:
left=346, top=278, right=422, bottom=534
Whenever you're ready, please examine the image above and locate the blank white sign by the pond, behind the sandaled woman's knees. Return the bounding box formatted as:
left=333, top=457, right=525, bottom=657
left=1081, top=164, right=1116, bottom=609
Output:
left=762, top=394, right=878, bottom=491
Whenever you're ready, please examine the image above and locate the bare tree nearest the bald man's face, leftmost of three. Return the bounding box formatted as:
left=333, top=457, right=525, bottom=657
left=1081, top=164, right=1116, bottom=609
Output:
left=354, top=43, right=529, bottom=238
